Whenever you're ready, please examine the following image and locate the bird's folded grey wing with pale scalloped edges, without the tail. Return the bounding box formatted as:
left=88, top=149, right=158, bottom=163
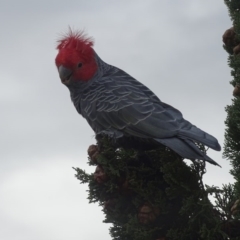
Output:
left=81, top=69, right=191, bottom=138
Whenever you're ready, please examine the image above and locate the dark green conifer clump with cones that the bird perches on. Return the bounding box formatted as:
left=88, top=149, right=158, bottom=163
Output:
left=75, top=138, right=238, bottom=240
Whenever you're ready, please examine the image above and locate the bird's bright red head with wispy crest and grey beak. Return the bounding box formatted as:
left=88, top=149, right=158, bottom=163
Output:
left=55, top=30, right=97, bottom=85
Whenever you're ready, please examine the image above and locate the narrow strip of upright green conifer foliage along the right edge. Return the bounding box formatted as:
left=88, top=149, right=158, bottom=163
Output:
left=224, top=0, right=240, bottom=198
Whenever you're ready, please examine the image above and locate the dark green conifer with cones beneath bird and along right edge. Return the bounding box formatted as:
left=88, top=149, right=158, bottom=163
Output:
left=75, top=0, right=240, bottom=240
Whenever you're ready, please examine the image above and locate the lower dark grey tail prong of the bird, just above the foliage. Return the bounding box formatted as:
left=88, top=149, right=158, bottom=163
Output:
left=155, top=138, right=221, bottom=167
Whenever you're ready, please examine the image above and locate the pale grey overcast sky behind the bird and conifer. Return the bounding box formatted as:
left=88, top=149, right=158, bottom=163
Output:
left=0, top=0, right=233, bottom=240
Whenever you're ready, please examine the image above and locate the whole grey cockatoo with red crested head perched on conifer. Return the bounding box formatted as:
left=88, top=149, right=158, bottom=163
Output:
left=55, top=29, right=221, bottom=166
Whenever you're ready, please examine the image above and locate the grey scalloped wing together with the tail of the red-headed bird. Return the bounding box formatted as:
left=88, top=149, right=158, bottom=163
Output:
left=81, top=68, right=220, bottom=163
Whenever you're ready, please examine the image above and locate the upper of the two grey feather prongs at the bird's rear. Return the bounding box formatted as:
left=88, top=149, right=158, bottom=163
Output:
left=178, top=126, right=221, bottom=151
